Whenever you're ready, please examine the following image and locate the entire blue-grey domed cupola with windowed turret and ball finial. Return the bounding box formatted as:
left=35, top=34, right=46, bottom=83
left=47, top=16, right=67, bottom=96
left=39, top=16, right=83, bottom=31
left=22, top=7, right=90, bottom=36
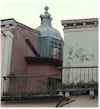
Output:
left=36, top=6, right=63, bottom=60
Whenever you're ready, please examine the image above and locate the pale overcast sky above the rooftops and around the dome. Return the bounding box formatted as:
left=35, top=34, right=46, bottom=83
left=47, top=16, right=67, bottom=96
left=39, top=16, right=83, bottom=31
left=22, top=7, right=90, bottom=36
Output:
left=0, top=0, right=97, bottom=36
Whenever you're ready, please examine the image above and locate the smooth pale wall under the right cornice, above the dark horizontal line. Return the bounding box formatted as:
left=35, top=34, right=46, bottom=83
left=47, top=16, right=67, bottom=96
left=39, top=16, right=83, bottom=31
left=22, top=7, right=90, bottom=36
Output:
left=63, top=28, right=98, bottom=66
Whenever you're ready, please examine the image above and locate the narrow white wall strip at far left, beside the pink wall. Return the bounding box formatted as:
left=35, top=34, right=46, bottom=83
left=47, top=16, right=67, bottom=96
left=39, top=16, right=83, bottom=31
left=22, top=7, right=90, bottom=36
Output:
left=1, top=31, right=13, bottom=93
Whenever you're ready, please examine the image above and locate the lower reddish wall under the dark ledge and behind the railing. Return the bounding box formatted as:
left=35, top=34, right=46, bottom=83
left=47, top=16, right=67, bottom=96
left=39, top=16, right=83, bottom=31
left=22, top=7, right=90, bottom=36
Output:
left=10, top=64, right=61, bottom=94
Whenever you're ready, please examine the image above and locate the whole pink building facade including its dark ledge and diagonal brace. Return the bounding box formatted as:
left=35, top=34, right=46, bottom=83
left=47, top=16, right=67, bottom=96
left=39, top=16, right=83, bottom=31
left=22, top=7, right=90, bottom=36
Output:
left=1, top=19, right=62, bottom=95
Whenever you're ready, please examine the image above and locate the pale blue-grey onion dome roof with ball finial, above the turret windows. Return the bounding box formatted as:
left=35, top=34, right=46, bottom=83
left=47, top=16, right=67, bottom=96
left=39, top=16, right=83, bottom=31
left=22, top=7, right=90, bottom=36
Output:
left=36, top=6, right=62, bottom=40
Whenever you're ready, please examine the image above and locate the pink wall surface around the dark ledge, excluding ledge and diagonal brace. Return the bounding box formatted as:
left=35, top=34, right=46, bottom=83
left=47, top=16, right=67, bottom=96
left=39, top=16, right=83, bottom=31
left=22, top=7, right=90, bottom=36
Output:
left=0, top=20, right=61, bottom=95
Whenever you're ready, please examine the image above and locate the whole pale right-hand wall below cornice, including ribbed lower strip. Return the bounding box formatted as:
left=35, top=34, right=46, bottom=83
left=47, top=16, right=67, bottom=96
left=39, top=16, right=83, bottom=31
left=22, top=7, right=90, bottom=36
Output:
left=62, top=21, right=98, bottom=84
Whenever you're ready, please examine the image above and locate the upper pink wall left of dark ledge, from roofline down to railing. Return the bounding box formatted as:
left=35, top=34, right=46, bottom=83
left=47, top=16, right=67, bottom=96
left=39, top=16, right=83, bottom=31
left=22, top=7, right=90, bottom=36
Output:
left=11, top=24, right=38, bottom=73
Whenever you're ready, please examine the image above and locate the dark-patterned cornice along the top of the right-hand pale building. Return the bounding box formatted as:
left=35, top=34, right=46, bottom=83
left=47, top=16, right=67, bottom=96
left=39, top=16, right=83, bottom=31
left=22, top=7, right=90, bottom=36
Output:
left=62, top=18, right=98, bottom=29
